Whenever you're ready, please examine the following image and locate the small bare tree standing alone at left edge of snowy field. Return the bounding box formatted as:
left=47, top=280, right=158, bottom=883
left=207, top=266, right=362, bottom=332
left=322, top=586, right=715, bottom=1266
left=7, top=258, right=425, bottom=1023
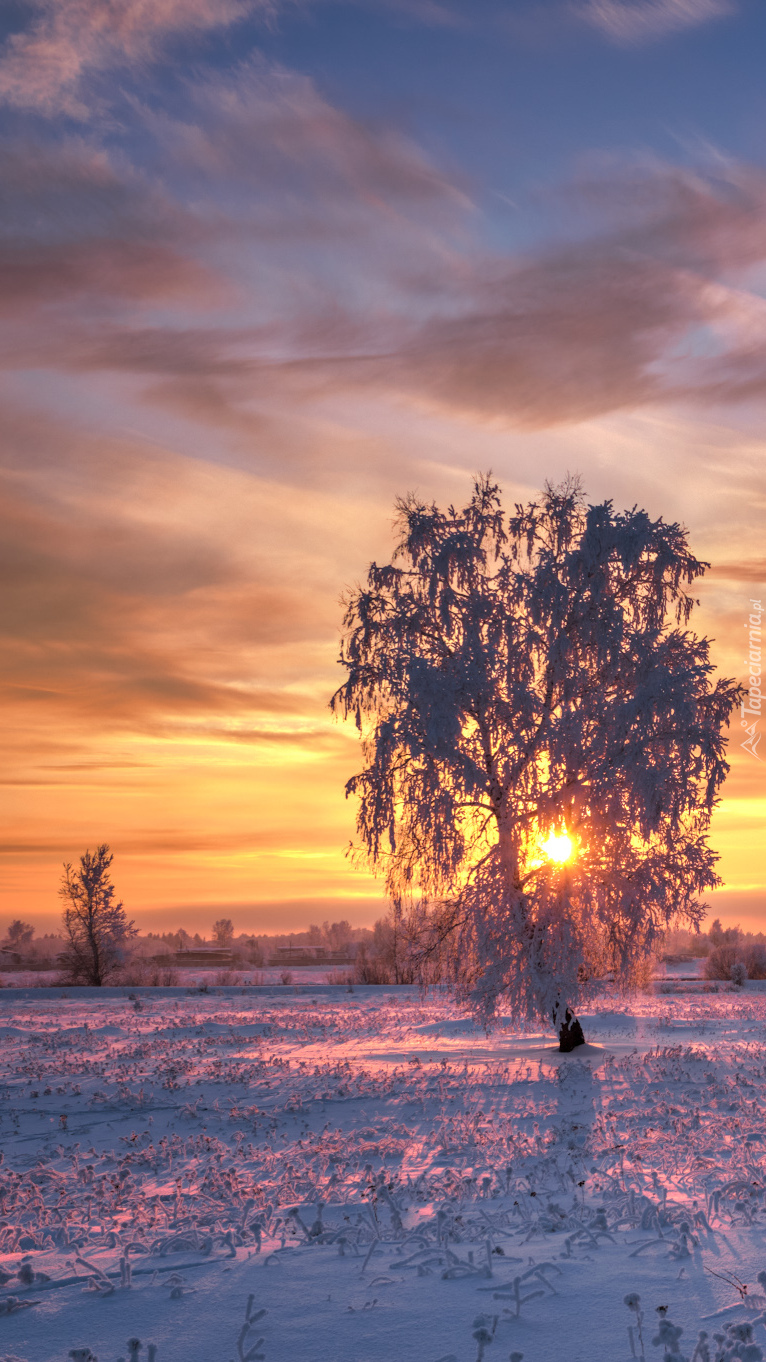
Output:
left=59, top=844, right=136, bottom=985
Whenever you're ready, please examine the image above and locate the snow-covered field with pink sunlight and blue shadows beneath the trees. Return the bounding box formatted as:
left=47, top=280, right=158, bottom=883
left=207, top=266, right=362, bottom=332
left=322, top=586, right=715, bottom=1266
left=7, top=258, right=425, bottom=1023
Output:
left=0, top=983, right=766, bottom=1362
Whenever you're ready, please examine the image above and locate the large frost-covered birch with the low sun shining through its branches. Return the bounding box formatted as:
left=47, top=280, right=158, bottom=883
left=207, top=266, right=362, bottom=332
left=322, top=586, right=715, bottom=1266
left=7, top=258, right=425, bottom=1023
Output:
left=333, top=477, right=739, bottom=1047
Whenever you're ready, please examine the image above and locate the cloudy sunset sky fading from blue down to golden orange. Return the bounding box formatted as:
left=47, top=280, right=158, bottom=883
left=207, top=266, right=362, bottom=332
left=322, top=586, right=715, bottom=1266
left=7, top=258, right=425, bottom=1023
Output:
left=0, top=0, right=766, bottom=932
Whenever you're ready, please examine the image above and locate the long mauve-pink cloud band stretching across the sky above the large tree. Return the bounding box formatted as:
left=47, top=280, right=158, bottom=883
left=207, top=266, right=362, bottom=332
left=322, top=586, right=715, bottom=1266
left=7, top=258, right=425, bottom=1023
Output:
left=7, top=153, right=766, bottom=440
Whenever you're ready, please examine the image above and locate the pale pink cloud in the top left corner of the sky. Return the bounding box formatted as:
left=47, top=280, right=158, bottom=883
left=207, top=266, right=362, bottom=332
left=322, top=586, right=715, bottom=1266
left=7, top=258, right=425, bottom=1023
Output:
left=0, top=0, right=265, bottom=118
